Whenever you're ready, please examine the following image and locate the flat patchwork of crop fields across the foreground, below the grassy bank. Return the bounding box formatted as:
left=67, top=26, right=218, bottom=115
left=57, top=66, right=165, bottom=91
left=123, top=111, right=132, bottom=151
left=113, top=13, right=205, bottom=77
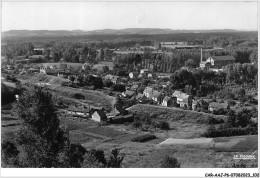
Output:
left=1, top=102, right=258, bottom=168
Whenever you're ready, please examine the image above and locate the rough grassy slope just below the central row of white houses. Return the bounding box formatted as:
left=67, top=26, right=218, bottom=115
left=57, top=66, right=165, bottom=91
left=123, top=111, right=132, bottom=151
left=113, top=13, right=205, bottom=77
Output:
left=129, top=105, right=226, bottom=138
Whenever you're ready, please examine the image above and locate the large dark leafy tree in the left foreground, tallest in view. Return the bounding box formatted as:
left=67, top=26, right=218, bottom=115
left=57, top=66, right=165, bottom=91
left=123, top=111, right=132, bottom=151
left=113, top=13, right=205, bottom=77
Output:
left=7, top=86, right=84, bottom=168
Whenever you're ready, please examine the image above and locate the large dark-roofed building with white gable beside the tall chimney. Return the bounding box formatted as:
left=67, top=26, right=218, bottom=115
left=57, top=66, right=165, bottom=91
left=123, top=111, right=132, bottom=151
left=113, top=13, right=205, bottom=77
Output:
left=206, top=56, right=236, bottom=69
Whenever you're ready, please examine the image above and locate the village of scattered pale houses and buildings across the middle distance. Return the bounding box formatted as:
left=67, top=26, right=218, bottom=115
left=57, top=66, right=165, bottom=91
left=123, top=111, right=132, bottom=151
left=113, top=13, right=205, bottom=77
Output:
left=2, top=42, right=257, bottom=122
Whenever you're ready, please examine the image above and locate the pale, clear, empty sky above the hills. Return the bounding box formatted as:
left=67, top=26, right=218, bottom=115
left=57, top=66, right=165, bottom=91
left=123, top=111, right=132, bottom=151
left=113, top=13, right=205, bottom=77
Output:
left=1, top=1, right=258, bottom=31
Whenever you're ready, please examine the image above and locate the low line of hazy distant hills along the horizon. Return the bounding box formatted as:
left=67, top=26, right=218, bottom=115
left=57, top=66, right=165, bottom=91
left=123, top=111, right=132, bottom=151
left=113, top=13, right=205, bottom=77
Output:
left=2, top=28, right=243, bottom=37
